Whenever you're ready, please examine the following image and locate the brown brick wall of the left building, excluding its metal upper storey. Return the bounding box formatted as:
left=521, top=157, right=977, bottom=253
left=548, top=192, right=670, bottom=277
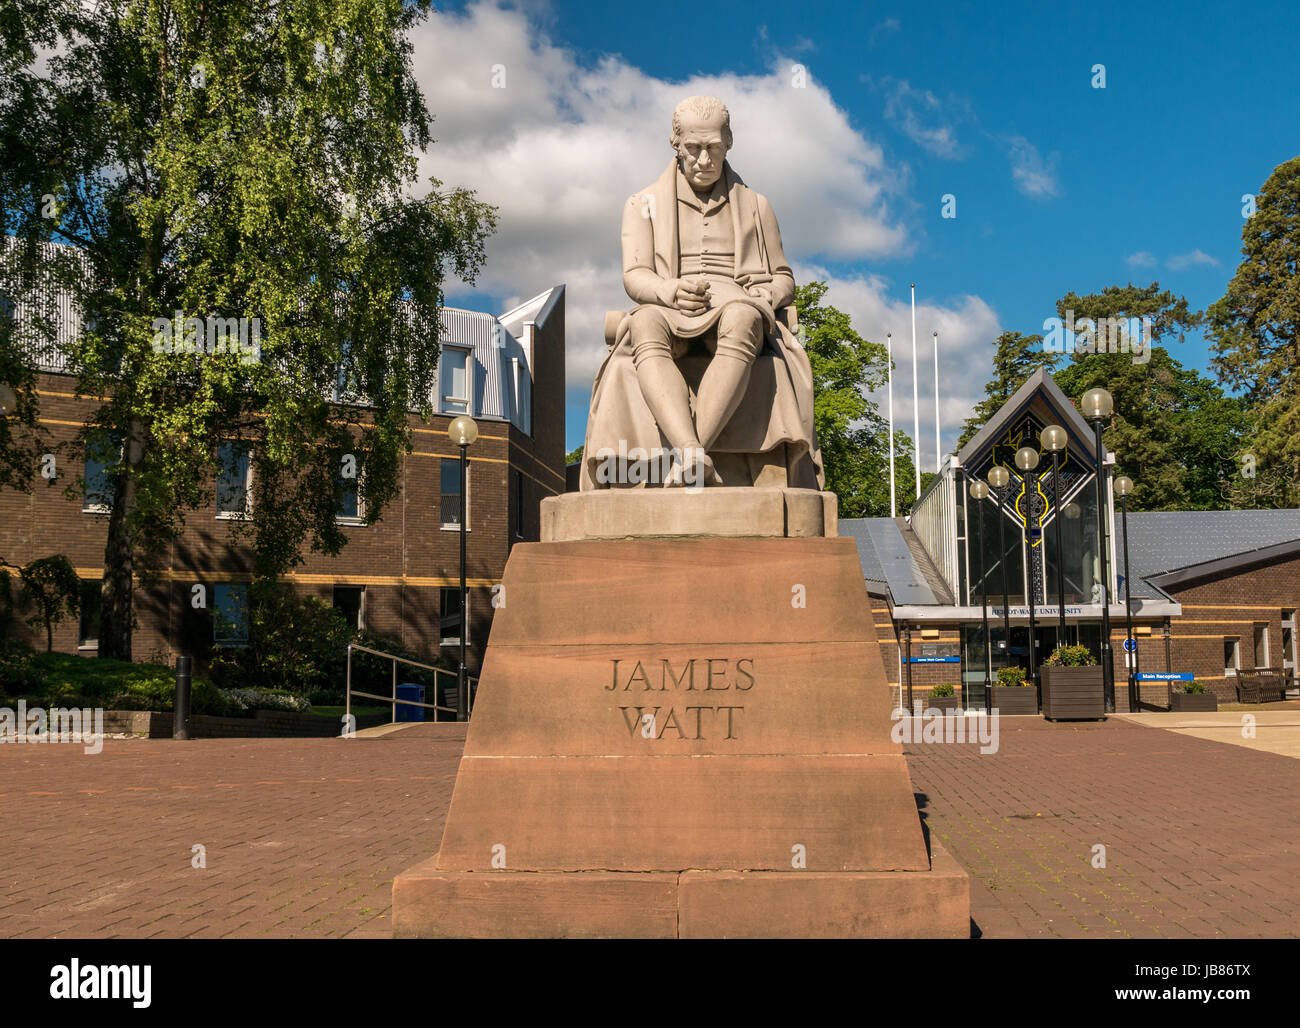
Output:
left=0, top=317, right=564, bottom=673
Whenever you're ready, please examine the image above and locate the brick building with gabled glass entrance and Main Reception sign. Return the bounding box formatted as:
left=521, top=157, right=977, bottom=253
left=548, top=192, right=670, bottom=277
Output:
left=840, top=372, right=1300, bottom=711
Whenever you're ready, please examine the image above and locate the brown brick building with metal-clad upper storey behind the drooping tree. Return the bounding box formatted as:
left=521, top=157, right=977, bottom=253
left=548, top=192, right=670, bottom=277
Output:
left=0, top=269, right=564, bottom=672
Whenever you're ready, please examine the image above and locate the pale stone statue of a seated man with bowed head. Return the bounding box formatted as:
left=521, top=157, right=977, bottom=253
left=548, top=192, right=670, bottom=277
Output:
left=581, top=96, right=824, bottom=490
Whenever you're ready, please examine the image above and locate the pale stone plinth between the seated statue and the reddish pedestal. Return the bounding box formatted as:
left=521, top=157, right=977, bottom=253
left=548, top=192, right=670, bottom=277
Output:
left=542, top=486, right=837, bottom=542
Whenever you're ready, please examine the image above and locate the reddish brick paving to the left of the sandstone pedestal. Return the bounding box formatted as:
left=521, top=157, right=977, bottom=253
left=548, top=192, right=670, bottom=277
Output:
left=0, top=726, right=464, bottom=937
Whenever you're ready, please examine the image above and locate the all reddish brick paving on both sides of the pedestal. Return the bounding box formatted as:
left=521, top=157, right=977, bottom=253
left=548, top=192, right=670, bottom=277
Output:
left=0, top=717, right=1300, bottom=937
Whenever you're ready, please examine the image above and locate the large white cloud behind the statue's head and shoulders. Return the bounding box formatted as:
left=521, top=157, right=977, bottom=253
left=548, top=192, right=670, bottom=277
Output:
left=412, top=3, right=910, bottom=389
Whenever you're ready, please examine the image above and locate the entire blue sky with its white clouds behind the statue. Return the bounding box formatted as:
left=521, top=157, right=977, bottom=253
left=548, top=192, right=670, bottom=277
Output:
left=416, top=3, right=1300, bottom=457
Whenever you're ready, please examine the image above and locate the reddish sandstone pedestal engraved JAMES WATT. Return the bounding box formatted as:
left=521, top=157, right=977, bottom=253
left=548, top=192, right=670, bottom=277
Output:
left=393, top=490, right=970, bottom=937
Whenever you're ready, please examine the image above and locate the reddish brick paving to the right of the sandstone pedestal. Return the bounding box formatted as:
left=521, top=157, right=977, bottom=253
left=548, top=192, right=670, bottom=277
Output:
left=905, top=717, right=1300, bottom=938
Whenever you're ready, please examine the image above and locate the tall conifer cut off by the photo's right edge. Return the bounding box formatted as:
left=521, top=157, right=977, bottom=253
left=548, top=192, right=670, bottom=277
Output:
left=1206, top=157, right=1300, bottom=507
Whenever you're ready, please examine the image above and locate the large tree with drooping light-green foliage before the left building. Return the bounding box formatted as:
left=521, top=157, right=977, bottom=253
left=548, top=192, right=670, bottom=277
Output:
left=0, top=0, right=495, bottom=659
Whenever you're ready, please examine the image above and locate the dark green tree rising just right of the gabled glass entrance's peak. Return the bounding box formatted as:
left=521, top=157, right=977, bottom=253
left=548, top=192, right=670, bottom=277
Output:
left=1054, top=282, right=1244, bottom=511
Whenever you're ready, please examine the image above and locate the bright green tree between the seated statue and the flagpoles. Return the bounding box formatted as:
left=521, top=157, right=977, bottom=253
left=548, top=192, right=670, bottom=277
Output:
left=794, top=282, right=915, bottom=517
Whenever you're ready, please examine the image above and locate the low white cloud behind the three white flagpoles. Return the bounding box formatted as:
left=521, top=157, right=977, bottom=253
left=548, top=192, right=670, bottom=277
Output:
left=794, top=264, right=1001, bottom=470
